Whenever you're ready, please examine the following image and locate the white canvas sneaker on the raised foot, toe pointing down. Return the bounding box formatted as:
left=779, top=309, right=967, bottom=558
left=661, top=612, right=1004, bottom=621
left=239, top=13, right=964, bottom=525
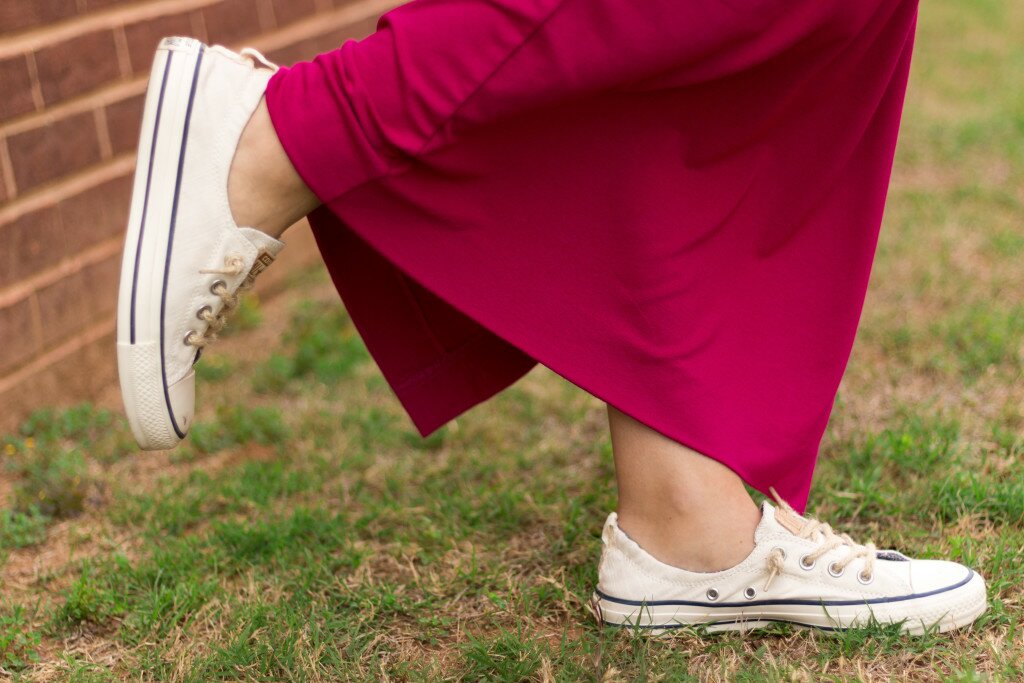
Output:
left=118, top=38, right=284, bottom=450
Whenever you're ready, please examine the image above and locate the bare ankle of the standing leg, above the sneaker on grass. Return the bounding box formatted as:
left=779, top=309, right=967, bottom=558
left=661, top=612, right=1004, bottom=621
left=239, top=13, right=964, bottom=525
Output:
left=608, top=404, right=761, bottom=571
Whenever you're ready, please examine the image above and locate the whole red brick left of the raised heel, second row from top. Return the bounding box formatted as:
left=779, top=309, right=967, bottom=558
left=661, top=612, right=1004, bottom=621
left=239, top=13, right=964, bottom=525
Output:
left=36, top=30, right=121, bottom=104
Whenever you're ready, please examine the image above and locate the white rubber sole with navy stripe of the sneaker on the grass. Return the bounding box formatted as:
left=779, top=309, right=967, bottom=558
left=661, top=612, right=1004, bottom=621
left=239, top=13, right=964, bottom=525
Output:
left=591, top=571, right=987, bottom=635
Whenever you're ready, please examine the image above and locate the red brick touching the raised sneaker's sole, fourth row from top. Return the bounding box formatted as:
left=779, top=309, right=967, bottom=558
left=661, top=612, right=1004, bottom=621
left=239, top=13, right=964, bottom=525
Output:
left=60, top=176, right=131, bottom=254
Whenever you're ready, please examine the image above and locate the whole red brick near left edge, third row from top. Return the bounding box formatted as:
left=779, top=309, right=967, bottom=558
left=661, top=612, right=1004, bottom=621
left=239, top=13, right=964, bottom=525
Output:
left=7, top=112, right=100, bottom=194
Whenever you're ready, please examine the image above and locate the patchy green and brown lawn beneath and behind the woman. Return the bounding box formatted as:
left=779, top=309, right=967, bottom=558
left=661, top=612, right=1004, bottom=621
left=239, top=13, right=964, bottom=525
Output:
left=0, top=0, right=1024, bottom=681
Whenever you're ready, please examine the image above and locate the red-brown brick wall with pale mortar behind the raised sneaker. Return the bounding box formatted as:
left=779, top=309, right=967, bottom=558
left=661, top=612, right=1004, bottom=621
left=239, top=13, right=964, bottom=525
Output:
left=0, top=0, right=397, bottom=429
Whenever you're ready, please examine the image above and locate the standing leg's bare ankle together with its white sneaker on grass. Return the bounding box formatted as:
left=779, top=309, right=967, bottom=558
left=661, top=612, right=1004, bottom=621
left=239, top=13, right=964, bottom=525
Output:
left=592, top=403, right=986, bottom=634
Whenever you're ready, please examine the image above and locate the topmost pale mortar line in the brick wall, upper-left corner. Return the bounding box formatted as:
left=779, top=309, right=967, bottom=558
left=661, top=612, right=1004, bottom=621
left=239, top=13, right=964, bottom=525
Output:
left=0, top=0, right=223, bottom=59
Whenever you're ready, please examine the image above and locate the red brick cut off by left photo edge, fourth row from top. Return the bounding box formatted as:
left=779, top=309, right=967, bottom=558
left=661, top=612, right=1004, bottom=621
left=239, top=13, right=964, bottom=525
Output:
left=0, top=206, right=66, bottom=288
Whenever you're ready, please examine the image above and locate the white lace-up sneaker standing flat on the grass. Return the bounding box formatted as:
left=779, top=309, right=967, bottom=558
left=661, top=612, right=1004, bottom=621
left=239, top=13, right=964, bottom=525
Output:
left=593, top=496, right=986, bottom=634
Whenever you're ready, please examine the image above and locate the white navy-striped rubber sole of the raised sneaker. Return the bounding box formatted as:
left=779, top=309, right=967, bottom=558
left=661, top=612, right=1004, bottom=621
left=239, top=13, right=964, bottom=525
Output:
left=117, top=38, right=205, bottom=451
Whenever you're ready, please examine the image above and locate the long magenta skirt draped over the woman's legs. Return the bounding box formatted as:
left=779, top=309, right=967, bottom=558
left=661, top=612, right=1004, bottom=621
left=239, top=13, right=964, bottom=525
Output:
left=267, top=0, right=918, bottom=510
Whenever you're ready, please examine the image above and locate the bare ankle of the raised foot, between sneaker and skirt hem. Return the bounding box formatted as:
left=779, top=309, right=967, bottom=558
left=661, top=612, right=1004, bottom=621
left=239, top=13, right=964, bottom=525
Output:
left=227, top=100, right=319, bottom=238
